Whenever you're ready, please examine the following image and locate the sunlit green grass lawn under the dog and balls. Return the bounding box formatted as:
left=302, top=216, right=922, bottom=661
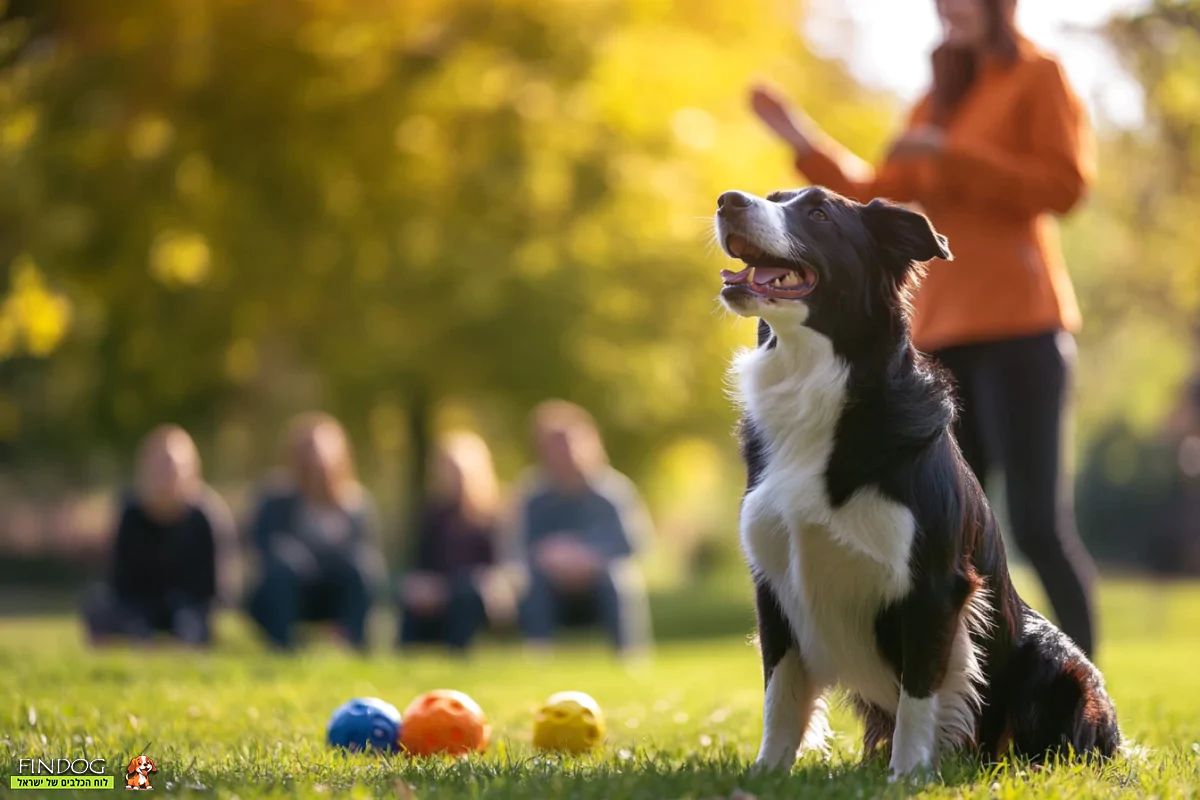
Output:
left=0, top=582, right=1200, bottom=800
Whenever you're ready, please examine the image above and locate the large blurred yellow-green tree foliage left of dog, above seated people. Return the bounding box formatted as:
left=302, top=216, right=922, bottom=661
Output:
left=0, top=0, right=895, bottom=522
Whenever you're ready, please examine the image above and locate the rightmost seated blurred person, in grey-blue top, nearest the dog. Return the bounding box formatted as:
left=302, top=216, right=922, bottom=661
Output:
left=508, top=401, right=652, bottom=655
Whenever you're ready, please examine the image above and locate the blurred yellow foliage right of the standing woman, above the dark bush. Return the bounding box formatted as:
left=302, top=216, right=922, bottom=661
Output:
left=1066, top=0, right=1200, bottom=443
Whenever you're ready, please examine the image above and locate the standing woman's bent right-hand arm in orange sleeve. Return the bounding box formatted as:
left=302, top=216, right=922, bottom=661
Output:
left=938, top=59, right=1094, bottom=215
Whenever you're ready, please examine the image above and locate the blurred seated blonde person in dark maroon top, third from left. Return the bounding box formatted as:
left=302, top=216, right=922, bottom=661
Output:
left=398, top=433, right=511, bottom=652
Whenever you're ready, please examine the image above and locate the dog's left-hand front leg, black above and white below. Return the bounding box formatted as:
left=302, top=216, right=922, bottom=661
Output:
left=755, top=576, right=829, bottom=770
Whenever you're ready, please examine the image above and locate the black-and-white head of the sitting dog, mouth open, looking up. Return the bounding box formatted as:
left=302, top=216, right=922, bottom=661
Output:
left=716, top=186, right=953, bottom=345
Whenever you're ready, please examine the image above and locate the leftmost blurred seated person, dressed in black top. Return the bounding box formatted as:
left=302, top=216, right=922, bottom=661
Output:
left=83, top=425, right=232, bottom=646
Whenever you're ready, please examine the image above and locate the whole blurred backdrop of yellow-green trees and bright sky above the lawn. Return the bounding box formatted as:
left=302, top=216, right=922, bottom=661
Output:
left=0, top=0, right=1200, bottom=597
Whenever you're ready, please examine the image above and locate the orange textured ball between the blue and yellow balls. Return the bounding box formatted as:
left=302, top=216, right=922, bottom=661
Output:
left=400, top=688, right=492, bottom=756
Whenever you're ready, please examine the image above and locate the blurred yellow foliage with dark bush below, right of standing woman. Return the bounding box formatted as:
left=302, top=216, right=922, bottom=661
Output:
left=1068, top=0, right=1200, bottom=569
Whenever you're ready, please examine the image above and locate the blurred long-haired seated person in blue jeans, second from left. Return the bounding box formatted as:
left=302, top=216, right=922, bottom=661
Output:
left=250, top=413, right=384, bottom=650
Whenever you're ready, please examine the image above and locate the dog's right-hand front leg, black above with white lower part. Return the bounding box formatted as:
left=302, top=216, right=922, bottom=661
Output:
left=892, top=578, right=965, bottom=780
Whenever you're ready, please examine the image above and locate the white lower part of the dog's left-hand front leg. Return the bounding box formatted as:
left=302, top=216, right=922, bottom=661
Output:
left=755, top=650, right=829, bottom=769
